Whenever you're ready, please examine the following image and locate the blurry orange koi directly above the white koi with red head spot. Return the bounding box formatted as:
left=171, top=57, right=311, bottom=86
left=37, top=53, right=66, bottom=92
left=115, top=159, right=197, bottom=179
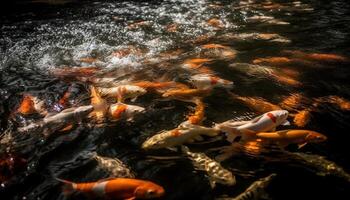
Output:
left=232, top=94, right=281, bottom=113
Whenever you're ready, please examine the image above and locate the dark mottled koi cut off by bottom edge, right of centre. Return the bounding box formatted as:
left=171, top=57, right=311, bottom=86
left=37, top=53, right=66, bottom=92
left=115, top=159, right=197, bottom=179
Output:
left=232, top=174, right=276, bottom=200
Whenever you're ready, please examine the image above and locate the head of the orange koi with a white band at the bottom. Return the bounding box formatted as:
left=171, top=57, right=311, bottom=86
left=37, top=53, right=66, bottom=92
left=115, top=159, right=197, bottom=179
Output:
left=135, top=182, right=165, bottom=199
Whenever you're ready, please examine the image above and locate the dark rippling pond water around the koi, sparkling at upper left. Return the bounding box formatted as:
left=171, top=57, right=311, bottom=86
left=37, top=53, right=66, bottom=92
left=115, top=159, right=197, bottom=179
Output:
left=0, top=0, right=350, bottom=199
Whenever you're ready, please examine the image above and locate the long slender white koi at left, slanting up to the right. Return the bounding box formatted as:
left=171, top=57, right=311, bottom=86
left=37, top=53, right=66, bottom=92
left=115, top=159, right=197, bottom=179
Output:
left=18, top=105, right=93, bottom=133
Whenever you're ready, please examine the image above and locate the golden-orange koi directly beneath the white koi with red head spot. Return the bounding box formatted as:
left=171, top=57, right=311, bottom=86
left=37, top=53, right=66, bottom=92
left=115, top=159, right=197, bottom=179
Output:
left=256, top=130, right=327, bottom=148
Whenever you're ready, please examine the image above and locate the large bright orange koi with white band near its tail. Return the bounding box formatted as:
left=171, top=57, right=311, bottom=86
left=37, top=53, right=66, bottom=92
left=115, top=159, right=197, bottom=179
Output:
left=57, top=178, right=165, bottom=200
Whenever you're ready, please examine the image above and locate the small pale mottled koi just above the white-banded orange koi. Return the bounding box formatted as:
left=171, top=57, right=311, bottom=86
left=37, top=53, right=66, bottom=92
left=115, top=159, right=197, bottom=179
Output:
left=92, top=152, right=135, bottom=178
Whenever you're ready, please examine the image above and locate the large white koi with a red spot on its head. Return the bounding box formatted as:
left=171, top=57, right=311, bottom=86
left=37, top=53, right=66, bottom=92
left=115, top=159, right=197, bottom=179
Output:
left=215, top=110, right=290, bottom=142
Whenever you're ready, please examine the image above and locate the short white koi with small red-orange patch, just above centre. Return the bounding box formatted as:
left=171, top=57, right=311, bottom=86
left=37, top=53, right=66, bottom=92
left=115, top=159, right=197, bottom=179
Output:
left=190, top=74, right=233, bottom=90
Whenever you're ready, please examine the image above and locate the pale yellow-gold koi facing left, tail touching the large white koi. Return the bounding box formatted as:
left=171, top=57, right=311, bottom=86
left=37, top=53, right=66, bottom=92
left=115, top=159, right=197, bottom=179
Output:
left=142, top=123, right=220, bottom=150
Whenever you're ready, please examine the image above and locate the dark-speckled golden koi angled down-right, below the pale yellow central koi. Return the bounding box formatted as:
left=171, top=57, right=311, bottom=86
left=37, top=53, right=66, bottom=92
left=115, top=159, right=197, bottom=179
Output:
left=181, top=146, right=236, bottom=187
